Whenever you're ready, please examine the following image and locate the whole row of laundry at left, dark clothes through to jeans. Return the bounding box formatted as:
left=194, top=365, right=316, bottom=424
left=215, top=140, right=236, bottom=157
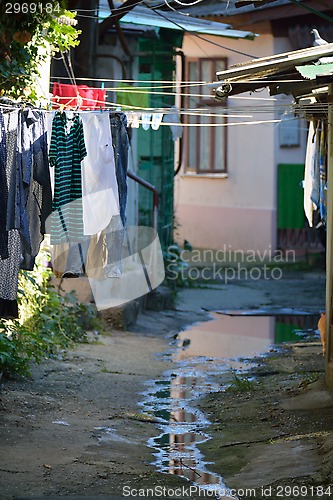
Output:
left=0, top=101, right=129, bottom=318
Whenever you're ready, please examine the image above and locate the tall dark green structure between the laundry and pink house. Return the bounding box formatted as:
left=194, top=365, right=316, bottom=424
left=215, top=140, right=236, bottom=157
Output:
left=138, top=30, right=182, bottom=249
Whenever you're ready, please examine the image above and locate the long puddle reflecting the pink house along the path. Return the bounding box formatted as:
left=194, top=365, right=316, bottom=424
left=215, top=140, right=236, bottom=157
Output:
left=141, top=313, right=319, bottom=500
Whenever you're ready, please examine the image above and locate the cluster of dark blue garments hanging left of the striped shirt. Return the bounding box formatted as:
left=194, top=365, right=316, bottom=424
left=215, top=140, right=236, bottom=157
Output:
left=0, top=108, right=51, bottom=318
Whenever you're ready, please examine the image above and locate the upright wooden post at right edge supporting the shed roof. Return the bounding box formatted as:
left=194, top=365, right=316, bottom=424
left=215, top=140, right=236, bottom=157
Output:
left=325, top=84, right=333, bottom=388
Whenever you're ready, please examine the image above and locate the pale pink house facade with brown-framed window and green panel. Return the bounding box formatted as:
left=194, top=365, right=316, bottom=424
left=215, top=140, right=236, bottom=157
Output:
left=175, top=0, right=333, bottom=254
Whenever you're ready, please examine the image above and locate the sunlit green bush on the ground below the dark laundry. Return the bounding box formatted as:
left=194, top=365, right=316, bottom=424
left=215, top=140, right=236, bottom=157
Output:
left=0, top=253, right=98, bottom=375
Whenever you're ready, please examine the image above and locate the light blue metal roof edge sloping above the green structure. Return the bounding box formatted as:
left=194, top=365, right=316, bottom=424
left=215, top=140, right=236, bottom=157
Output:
left=99, top=0, right=256, bottom=40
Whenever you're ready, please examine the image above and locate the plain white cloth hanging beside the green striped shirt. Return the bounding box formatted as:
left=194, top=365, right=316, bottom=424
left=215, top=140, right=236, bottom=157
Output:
left=81, top=112, right=119, bottom=235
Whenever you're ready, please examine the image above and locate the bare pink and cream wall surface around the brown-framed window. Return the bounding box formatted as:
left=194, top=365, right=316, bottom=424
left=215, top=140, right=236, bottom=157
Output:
left=175, top=28, right=304, bottom=252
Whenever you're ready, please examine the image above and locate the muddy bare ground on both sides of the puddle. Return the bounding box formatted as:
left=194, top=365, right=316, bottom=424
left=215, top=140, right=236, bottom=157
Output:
left=0, top=269, right=333, bottom=500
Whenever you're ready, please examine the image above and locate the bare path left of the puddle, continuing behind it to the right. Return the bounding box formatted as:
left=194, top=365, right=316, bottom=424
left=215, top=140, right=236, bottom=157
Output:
left=0, top=272, right=326, bottom=500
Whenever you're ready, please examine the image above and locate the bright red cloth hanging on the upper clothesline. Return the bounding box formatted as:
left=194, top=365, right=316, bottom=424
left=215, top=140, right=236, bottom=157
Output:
left=51, top=82, right=106, bottom=109
